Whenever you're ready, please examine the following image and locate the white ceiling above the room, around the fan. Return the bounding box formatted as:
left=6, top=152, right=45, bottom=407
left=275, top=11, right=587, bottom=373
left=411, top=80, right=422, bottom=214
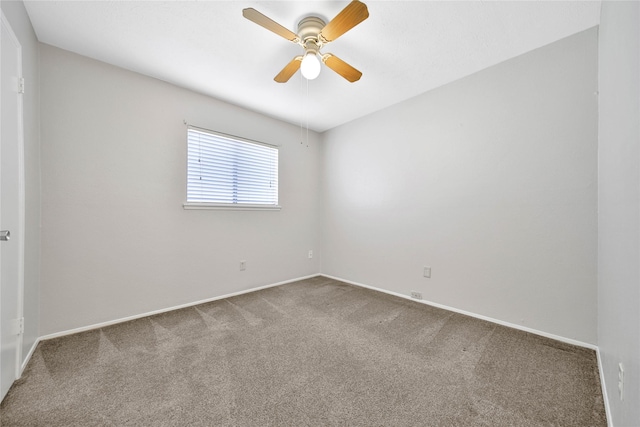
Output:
left=25, top=0, right=600, bottom=132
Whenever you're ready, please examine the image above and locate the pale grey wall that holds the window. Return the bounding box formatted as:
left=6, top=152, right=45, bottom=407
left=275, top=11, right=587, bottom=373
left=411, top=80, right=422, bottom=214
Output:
left=40, top=45, right=320, bottom=335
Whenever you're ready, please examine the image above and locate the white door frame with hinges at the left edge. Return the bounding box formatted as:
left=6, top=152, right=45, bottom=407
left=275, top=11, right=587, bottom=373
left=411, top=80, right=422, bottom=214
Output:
left=0, top=10, right=26, bottom=392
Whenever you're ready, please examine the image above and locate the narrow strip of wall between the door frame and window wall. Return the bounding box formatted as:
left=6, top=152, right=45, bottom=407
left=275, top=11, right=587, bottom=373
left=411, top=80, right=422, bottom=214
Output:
left=0, top=1, right=40, bottom=368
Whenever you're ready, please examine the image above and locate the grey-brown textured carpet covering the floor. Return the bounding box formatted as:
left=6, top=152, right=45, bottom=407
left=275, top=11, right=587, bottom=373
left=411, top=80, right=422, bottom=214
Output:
left=0, top=277, right=606, bottom=427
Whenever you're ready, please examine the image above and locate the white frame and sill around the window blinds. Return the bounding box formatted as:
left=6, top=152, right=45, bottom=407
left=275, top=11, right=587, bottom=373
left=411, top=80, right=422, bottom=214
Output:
left=182, top=125, right=282, bottom=211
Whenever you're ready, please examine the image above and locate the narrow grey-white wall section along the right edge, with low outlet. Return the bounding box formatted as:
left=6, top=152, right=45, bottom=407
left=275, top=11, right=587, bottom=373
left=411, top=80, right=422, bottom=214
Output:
left=598, top=1, right=640, bottom=426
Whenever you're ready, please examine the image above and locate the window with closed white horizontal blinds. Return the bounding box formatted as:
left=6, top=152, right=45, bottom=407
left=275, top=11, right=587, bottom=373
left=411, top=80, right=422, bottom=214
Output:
left=184, top=127, right=280, bottom=209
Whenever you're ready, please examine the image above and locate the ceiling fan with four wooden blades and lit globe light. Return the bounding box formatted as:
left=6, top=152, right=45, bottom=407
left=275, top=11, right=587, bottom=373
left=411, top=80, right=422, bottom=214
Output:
left=242, top=0, right=369, bottom=83
